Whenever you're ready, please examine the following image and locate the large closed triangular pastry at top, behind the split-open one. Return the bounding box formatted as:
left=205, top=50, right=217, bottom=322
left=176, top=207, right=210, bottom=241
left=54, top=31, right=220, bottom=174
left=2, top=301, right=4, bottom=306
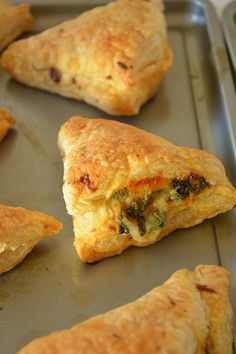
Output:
left=1, top=0, right=172, bottom=115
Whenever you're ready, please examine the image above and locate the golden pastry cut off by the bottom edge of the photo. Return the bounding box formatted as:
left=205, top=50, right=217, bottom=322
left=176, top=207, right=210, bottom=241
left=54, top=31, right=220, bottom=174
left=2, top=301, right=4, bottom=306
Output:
left=18, top=265, right=232, bottom=354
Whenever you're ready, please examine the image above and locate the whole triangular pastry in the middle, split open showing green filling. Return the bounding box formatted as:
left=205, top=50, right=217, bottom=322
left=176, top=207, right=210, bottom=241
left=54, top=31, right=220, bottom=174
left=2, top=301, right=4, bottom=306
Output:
left=58, top=116, right=236, bottom=262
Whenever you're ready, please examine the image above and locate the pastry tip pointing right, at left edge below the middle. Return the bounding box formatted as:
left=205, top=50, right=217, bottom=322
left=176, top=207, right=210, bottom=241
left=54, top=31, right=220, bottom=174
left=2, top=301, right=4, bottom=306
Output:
left=0, top=205, right=62, bottom=274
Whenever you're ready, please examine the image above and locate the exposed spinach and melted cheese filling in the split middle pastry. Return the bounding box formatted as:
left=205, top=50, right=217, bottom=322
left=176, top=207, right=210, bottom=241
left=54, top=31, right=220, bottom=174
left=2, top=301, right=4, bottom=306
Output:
left=111, top=174, right=209, bottom=241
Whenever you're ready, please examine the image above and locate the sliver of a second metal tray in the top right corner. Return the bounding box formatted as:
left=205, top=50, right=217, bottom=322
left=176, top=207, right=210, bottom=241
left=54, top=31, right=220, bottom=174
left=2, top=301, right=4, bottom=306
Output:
left=222, top=1, right=236, bottom=80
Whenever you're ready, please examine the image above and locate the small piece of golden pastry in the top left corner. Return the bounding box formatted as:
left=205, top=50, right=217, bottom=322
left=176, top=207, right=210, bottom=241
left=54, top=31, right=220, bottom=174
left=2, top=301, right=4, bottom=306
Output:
left=0, top=2, right=33, bottom=51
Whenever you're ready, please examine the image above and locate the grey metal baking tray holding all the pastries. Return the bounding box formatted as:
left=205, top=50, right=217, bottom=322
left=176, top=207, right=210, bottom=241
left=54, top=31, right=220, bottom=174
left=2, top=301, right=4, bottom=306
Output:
left=0, top=0, right=236, bottom=354
